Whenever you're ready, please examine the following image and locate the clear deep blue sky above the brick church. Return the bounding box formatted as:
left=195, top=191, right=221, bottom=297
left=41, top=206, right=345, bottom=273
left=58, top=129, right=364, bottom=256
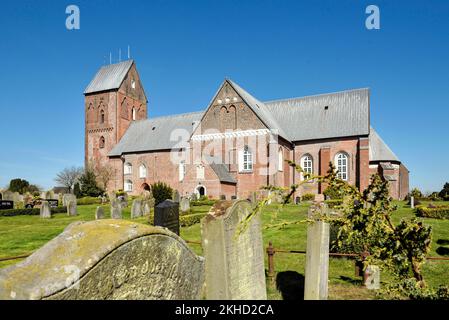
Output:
left=0, top=0, right=449, bottom=191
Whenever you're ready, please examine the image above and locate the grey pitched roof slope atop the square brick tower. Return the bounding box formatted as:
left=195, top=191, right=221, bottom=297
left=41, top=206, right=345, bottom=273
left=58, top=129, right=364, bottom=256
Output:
left=84, top=60, right=134, bottom=94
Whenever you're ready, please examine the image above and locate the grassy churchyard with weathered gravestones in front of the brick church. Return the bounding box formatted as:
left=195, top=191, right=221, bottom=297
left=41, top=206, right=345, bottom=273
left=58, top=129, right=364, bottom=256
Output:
left=0, top=182, right=449, bottom=300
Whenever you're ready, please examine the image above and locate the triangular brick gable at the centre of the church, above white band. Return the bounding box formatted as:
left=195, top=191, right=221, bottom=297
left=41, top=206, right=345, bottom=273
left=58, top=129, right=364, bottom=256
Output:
left=194, top=80, right=267, bottom=134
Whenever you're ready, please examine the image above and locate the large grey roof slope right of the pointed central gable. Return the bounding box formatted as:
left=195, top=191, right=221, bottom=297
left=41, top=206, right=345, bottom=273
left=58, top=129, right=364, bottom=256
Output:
left=265, top=88, right=370, bottom=141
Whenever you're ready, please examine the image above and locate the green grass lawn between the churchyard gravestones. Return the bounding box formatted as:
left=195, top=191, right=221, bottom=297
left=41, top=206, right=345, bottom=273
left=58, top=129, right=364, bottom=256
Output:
left=0, top=202, right=449, bottom=299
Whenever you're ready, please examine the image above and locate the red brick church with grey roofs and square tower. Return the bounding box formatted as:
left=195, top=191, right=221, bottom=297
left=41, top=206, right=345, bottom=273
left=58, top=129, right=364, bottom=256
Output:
left=84, top=60, right=409, bottom=199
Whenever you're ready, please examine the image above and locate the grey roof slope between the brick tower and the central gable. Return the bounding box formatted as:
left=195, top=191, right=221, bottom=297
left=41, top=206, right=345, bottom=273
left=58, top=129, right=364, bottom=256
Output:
left=109, top=112, right=203, bottom=156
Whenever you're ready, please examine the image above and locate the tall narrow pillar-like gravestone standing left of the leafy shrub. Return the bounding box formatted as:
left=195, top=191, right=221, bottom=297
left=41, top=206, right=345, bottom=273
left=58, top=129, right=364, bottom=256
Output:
left=304, top=202, right=329, bottom=300
